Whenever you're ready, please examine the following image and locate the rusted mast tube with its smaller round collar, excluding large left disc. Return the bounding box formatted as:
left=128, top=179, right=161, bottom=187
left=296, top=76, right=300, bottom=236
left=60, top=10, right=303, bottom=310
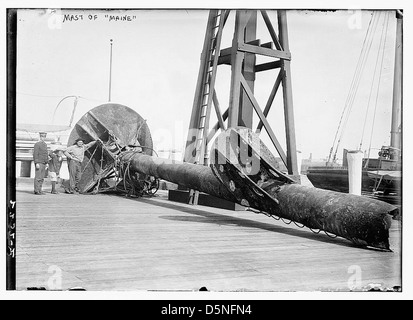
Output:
left=120, top=129, right=397, bottom=250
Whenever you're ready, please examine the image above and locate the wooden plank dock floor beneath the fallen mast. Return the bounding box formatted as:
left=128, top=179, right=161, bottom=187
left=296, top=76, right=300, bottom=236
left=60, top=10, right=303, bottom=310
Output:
left=16, top=179, right=402, bottom=292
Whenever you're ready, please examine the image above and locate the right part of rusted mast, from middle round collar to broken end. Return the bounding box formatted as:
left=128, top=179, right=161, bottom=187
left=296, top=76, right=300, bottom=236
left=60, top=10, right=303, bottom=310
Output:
left=212, top=129, right=398, bottom=249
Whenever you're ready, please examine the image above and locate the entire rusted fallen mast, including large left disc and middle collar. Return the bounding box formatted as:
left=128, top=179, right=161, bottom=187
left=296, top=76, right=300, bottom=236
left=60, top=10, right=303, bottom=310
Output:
left=69, top=104, right=398, bottom=250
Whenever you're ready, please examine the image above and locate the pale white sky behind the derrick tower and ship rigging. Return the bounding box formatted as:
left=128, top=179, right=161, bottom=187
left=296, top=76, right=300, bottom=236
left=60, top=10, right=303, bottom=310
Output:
left=16, top=9, right=396, bottom=158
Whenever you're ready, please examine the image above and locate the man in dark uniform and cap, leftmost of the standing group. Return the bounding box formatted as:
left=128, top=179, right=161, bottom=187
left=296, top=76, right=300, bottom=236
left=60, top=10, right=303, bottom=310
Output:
left=33, top=132, right=49, bottom=195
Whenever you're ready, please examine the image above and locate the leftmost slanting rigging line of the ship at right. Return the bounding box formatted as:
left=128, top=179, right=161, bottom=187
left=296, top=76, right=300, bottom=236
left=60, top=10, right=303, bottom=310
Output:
left=333, top=12, right=379, bottom=162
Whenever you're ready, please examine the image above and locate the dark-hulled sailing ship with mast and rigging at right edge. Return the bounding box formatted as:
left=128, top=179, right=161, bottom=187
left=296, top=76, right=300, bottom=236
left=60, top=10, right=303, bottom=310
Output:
left=306, top=10, right=403, bottom=204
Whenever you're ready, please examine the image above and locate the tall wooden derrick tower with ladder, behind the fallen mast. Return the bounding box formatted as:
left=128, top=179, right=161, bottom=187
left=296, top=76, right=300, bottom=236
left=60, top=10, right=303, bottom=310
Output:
left=184, top=10, right=299, bottom=204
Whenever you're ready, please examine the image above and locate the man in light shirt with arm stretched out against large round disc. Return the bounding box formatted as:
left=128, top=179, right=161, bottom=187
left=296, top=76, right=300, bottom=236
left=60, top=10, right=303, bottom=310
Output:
left=64, top=138, right=100, bottom=194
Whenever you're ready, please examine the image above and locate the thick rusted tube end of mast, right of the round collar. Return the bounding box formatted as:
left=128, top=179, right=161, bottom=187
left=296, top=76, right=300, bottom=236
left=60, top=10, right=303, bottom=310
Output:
left=274, top=185, right=392, bottom=249
